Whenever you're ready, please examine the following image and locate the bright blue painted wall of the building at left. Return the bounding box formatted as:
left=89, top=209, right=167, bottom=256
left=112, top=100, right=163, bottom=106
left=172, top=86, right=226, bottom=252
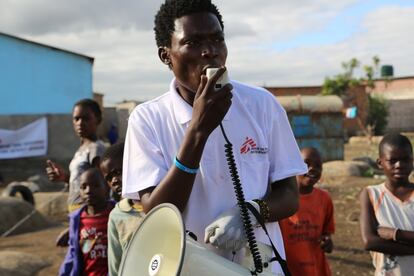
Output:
left=0, top=33, right=93, bottom=115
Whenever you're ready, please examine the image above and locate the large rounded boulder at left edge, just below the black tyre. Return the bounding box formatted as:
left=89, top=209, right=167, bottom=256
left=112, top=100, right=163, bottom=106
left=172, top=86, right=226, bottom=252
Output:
left=0, top=197, right=51, bottom=235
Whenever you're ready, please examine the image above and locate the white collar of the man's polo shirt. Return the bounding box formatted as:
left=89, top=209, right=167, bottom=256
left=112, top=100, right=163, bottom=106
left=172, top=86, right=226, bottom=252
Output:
left=170, top=78, right=235, bottom=124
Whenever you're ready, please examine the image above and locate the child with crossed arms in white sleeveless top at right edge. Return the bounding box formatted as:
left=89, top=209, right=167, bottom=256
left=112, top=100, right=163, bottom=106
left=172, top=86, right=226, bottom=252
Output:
left=360, top=134, right=414, bottom=275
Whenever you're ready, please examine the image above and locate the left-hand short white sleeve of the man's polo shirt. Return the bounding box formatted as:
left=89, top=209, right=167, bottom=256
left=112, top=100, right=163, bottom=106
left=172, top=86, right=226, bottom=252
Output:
left=122, top=108, right=168, bottom=199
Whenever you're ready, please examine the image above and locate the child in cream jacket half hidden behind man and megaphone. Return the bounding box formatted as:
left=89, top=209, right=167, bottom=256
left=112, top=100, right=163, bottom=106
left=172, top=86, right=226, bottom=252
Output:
left=100, top=143, right=144, bottom=276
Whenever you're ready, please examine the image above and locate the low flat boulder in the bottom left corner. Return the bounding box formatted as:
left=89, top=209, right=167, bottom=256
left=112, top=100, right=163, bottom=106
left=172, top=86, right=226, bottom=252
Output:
left=0, top=250, right=50, bottom=276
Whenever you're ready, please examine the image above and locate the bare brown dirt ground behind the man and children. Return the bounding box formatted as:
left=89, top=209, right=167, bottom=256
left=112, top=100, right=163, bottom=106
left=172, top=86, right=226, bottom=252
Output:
left=0, top=136, right=414, bottom=275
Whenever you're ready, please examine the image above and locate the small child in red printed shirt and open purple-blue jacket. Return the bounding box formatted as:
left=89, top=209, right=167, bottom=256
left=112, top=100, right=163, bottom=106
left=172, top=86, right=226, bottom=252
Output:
left=59, top=167, right=114, bottom=276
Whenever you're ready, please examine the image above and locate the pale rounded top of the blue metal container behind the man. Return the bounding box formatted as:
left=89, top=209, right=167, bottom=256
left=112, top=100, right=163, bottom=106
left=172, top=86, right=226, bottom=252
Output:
left=276, top=95, right=343, bottom=113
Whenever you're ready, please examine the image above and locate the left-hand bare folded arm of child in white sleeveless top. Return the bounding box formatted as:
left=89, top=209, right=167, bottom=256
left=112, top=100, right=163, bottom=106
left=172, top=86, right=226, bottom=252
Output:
left=360, top=189, right=414, bottom=255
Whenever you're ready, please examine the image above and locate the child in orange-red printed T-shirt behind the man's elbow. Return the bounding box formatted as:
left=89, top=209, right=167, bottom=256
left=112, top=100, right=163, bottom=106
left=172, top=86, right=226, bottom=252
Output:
left=280, top=148, right=335, bottom=276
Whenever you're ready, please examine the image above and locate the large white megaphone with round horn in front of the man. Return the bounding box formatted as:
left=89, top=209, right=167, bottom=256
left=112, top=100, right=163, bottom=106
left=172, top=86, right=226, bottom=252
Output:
left=120, top=203, right=273, bottom=276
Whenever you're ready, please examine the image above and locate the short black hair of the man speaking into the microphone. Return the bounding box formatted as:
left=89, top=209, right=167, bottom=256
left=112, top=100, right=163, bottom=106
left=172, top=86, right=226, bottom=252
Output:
left=154, top=0, right=224, bottom=47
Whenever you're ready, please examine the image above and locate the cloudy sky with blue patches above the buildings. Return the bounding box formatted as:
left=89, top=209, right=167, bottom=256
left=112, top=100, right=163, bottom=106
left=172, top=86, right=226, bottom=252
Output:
left=0, top=0, right=414, bottom=106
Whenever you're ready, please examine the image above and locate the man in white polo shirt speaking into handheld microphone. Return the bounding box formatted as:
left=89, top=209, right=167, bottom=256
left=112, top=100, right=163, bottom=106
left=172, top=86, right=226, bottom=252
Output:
left=123, top=0, right=307, bottom=273
